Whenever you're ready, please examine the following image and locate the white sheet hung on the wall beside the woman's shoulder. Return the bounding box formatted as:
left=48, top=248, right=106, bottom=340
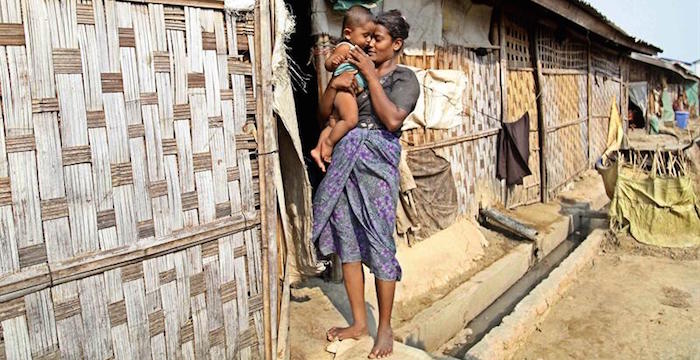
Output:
left=402, top=70, right=468, bottom=130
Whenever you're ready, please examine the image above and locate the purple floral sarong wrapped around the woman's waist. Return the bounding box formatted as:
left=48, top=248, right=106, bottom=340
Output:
left=313, top=127, right=401, bottom=281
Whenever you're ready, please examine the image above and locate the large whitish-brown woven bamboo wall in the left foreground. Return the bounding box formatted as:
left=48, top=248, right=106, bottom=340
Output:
left=0, top=0, right=264, bottom=359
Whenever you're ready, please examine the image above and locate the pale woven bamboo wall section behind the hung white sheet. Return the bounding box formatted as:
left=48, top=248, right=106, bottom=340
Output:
left=402, top=47, right=502, bottom=215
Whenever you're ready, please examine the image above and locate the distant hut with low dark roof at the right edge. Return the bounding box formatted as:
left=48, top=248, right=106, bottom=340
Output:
left=630, top=53, right=700, bottom=127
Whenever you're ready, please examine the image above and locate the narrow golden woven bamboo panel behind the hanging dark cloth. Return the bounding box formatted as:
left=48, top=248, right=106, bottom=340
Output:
left=506, top=70, right=540, bottom=207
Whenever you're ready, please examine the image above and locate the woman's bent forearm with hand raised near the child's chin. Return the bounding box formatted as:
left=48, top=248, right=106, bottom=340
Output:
left=348, top=48, right=408, bottom=132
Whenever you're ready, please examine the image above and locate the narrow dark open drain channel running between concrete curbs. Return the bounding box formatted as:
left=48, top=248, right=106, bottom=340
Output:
left=443, top=218, right=598, bottom=359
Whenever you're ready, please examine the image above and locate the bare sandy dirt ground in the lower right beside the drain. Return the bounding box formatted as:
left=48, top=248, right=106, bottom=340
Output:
left=513, top=250, right=700, bottom=359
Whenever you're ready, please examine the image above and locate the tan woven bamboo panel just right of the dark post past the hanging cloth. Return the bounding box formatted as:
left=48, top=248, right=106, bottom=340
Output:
left=542, top=75, right=588, bottom=196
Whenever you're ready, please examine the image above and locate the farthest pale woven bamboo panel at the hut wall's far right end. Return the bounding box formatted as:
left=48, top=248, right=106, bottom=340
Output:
left=590, top=75, right=620, bottom=163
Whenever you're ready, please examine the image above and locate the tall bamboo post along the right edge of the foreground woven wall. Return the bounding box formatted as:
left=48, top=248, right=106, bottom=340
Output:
left=255, top=0, right=279, bottom=360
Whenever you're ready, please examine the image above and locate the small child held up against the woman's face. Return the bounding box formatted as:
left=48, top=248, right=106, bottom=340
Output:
left=311, top=5, right=374, bottom=172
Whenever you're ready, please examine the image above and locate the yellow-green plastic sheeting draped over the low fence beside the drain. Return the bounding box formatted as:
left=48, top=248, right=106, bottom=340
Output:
left=610, top=166, right=700, bottom=248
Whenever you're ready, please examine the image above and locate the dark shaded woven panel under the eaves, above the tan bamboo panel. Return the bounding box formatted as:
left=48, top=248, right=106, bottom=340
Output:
left=537, top=27, right=588, bottom=70
